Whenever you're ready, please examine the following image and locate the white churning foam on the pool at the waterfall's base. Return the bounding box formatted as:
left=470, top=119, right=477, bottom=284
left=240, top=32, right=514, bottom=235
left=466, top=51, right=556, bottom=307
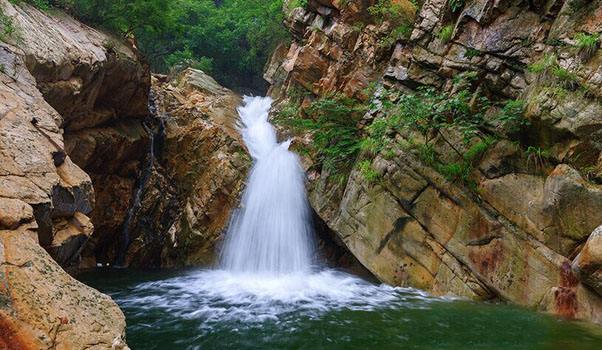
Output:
left=114, top=270, right=441, bottom=328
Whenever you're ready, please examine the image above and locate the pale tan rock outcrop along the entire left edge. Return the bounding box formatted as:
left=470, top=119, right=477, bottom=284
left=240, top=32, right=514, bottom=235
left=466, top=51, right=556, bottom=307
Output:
left=0, top=0, right=145, bottom=349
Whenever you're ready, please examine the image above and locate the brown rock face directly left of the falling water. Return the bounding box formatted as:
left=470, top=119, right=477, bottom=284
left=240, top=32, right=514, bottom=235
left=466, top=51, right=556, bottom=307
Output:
left=153, top=69, right=251, bottom=266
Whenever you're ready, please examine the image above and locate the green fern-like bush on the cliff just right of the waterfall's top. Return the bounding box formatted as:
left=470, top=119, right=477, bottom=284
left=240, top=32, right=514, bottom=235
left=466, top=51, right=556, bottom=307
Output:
left=275, top=96, right=366, bottom=175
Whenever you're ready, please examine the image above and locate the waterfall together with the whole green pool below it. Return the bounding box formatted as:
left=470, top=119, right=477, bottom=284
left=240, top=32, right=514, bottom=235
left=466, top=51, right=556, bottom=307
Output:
left=81, top=97, right=602, bottom=350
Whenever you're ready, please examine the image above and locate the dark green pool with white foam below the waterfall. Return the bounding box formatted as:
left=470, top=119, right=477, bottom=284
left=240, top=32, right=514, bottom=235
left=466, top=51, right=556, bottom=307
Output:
left=80, top=270, right=602, bottom=350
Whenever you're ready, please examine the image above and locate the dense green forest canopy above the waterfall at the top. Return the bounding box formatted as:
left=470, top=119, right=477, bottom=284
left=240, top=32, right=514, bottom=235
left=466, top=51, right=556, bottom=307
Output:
left=16, top=0, right=287, bottom=92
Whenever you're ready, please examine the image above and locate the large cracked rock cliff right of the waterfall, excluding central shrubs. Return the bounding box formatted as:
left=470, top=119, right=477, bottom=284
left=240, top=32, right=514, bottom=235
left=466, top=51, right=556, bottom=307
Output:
left=266, top=0, right=602, bottom=323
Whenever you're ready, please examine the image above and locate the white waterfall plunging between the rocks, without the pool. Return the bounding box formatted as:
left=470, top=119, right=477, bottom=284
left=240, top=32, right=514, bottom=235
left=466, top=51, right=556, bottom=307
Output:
left=221, top=96, right=314, bottom=275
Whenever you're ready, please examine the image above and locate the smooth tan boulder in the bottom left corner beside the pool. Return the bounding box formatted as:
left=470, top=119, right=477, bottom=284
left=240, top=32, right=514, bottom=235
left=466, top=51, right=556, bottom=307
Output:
left=0, top=228, right=127, bottom=350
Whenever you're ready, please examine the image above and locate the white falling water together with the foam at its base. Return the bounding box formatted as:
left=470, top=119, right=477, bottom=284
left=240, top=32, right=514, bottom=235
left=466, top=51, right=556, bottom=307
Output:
left=110, top=97, right=442, bottom=332
